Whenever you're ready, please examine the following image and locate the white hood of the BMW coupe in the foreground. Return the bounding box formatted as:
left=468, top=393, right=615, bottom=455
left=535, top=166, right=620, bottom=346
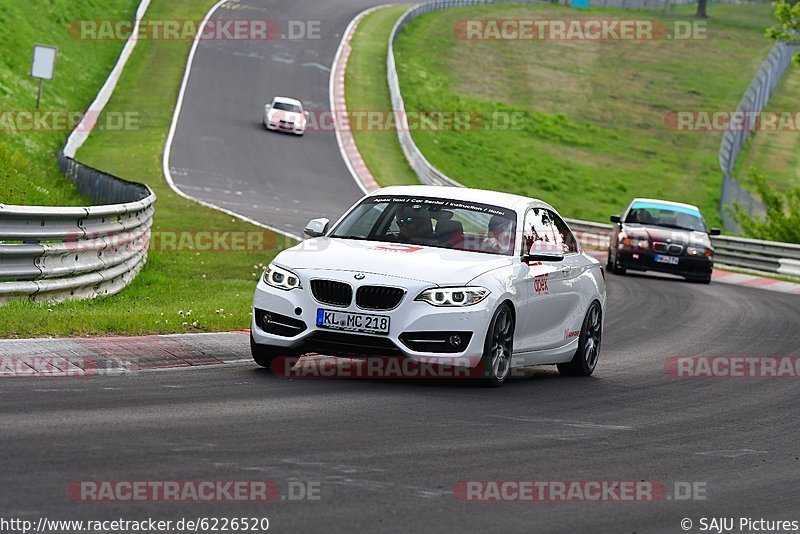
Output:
left=275, top=237, right=513, bottom=285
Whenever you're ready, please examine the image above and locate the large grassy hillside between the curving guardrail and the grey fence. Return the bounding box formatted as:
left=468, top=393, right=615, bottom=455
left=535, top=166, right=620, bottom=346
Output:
left=396, top=4, right=772, bottom=225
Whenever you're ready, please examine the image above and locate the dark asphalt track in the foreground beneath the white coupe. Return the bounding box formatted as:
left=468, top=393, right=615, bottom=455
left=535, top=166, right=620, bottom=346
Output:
left=0, top=276, right=800, bottom=533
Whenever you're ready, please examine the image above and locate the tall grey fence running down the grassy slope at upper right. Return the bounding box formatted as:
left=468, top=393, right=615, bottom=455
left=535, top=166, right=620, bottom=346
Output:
left=719, top=43, right=800, bottom=233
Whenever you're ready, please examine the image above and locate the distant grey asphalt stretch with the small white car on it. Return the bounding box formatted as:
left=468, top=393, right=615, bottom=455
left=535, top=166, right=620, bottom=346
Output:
left=169, top=0, right=377, bottom=235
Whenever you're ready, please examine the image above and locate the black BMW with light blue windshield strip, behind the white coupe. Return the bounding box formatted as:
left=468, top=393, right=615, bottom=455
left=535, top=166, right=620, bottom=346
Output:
left=606, top=198, right=720, bottom=284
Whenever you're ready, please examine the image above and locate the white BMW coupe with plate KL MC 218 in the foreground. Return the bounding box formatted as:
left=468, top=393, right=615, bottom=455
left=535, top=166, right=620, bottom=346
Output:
left=250, top=186, right=606, bottom=386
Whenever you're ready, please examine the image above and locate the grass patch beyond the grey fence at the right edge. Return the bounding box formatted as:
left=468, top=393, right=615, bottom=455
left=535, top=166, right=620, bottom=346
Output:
left=735, top=65, right=800, bottom=191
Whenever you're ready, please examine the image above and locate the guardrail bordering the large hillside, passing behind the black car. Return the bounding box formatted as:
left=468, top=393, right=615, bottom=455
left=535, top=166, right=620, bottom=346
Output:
left=386, top=0, right=800, bottom=278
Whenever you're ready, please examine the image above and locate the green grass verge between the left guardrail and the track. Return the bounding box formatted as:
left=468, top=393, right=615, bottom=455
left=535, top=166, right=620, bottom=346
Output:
left=0, top=0, right=294, bottom=337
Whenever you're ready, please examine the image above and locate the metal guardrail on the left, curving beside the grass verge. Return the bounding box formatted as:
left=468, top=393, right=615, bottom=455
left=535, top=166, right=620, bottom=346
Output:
left=0, top=0, right=156, bottom=305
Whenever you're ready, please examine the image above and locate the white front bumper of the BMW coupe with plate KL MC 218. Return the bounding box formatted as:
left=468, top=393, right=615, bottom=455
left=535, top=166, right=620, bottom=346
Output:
left=251, top=271, right=494, bottom=367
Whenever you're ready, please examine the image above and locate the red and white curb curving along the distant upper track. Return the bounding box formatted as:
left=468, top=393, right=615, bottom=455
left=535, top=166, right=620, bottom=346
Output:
left=330, top=4, right=389, bottom=197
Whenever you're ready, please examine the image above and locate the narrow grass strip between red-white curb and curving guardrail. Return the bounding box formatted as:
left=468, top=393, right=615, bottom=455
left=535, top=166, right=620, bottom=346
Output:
left=345, top=5, right=419, bottom=187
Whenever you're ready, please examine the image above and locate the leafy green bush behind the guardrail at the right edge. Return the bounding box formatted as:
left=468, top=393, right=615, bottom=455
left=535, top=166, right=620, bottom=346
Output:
left=730, top=169, right=800, bottom=243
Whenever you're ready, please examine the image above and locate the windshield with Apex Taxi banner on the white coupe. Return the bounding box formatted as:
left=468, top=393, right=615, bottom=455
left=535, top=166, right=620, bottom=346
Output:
left=330, top=197, right=516, bottom=256
